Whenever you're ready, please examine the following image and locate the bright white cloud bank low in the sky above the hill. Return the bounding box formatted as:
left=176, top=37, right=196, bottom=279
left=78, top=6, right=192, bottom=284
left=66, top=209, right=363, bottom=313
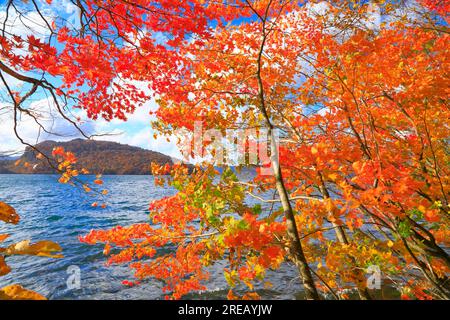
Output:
left=0, top=95, right=182, bottom=159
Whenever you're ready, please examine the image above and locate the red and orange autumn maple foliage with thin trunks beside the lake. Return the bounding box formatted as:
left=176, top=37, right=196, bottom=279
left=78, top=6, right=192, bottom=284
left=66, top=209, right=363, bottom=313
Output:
left=0, top=0, right=450, bottom=299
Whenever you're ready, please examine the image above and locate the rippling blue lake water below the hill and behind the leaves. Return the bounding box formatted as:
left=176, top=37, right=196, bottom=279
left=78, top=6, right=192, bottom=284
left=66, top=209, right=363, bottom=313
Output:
left=0, top=175, right=303, bottom=299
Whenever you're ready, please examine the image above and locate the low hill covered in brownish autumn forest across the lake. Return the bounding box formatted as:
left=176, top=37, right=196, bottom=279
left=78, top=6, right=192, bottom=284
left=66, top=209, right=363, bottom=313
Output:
left=0, top=139, right=178, bottom=175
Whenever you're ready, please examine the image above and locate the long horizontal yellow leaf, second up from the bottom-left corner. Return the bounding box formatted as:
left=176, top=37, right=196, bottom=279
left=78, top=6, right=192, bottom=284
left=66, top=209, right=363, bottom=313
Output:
left=4, top=240, right=63, bottom=258
